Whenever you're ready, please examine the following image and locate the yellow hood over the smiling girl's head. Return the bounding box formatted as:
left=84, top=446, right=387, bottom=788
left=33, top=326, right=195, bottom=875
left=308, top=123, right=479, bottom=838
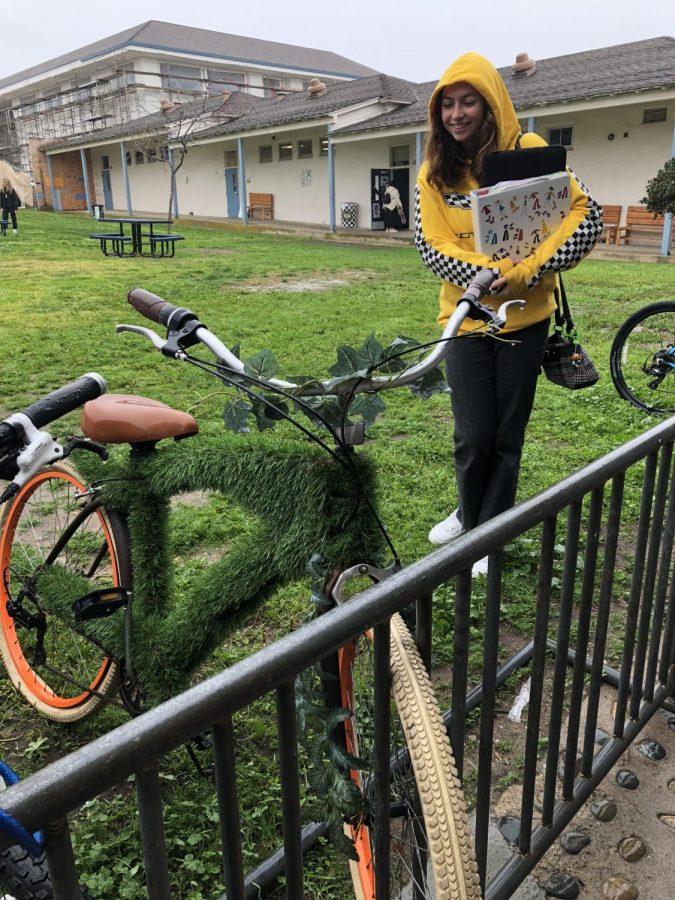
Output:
left=429, top=53, right=520, bottom=150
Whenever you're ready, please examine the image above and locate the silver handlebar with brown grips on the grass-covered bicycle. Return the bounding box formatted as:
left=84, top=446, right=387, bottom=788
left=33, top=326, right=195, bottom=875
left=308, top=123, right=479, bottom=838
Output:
left=117, top=269, right=524, bottom=396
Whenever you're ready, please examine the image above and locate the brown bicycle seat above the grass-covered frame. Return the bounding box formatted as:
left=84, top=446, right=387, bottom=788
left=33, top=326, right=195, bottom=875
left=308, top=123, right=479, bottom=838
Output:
left=81, top=394, right=199, bottom=444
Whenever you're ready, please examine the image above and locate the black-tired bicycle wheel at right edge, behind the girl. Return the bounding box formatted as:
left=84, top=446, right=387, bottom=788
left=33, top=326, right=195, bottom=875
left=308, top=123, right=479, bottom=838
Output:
left=609, top=300, right=675, bottom=414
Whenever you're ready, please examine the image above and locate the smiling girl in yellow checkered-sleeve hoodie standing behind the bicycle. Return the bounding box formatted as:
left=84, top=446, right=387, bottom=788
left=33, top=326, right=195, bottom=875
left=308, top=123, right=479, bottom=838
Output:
left=415, top=53, right=602, bottom=574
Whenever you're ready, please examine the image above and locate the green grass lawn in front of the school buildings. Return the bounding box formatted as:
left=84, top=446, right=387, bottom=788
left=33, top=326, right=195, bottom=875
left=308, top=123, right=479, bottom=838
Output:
left=0, top=210, right=673, bottom=900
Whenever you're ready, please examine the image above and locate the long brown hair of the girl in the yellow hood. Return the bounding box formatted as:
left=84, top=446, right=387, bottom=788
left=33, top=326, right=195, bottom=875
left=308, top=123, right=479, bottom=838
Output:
left=424, top=91, right=499, bottom=191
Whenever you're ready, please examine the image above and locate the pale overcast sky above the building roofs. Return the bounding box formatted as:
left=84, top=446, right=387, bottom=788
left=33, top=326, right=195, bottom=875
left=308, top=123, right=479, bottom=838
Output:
left=0, top=0, right=675, bottom=81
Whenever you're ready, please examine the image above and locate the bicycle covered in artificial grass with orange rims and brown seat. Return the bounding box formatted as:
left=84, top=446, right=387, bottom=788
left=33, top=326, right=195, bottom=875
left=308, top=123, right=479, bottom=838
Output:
left=0, top=273, right=519, bottom=900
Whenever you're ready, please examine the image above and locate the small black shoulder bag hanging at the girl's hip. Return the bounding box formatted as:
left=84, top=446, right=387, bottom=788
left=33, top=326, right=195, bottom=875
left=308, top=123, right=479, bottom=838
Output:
left=542, top=275, right=600, bottom=391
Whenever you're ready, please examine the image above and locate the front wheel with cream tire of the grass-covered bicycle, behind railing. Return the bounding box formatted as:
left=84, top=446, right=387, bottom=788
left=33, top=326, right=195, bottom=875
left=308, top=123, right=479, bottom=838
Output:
left=338, top=615, right=481, bottom=900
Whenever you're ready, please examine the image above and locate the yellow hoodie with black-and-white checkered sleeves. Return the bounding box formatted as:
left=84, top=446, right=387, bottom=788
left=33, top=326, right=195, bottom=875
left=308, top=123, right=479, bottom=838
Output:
left=415, top=53, right=602, bottom=331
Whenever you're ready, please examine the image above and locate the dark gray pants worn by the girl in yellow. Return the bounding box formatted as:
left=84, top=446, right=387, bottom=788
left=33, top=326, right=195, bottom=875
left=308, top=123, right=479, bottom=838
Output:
left=447, top=319, right=549, bottom=529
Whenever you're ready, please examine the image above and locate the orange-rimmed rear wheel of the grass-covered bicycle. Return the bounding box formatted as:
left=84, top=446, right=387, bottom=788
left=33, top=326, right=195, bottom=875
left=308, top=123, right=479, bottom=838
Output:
left=0, top=463, right=131, bottom=723
